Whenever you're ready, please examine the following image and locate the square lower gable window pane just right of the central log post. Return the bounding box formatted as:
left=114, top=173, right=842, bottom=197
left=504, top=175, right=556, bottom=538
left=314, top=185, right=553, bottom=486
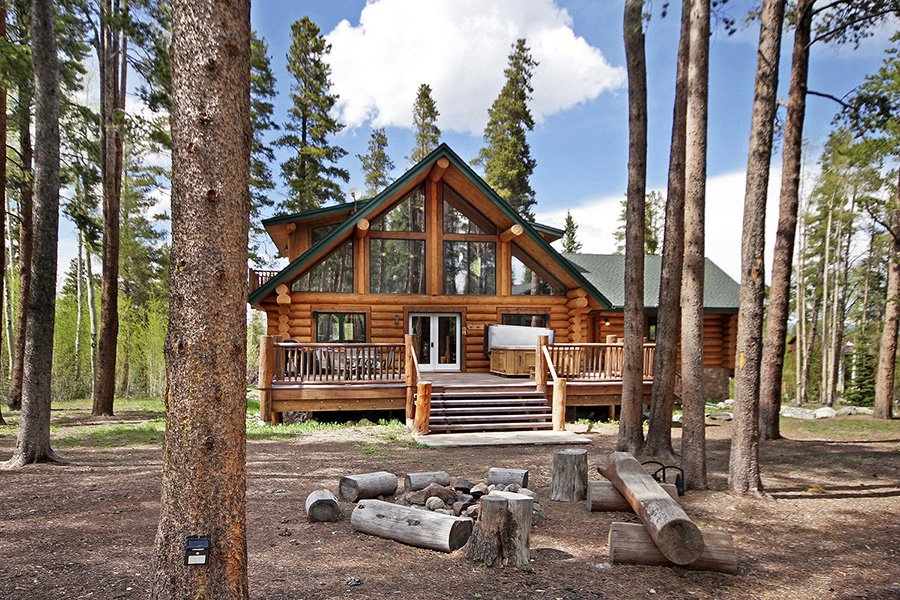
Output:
left=444, top=242, right=497, bottom=296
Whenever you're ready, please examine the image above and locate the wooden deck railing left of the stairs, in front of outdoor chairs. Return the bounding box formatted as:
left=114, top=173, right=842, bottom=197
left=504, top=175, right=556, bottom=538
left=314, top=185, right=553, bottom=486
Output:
left=273, top=342, right=406, bottom=384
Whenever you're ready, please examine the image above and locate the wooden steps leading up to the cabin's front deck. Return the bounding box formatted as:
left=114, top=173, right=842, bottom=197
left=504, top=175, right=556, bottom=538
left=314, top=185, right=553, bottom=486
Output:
left=429, top=383, right=553, bottom=433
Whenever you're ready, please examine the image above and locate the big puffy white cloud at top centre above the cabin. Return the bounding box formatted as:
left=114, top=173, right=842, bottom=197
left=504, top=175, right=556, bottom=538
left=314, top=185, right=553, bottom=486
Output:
left=326, top=0, right=625, bottom=134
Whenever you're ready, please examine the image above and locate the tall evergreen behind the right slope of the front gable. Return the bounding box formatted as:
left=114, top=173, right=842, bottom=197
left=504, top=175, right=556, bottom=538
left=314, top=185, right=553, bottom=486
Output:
left=472, top=38, right=537, bottom=221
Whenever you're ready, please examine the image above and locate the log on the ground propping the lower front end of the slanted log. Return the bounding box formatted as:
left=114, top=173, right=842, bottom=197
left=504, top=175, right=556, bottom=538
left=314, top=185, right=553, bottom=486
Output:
left=609, top=523, right=737, bottom=575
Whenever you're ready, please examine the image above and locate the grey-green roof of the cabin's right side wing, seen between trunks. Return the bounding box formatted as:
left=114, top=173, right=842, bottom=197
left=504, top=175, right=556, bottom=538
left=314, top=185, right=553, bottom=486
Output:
left=563, top=254, right=740, bottom=312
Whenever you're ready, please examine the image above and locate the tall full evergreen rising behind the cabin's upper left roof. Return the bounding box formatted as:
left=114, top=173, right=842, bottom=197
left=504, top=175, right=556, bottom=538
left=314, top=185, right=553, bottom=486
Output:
left=276, top=17, right=350, bottom=211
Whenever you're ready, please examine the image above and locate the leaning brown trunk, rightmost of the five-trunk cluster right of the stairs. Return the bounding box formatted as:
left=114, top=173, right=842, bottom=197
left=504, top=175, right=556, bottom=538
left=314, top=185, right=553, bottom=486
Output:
left=759, top=0, right=815, bottom=440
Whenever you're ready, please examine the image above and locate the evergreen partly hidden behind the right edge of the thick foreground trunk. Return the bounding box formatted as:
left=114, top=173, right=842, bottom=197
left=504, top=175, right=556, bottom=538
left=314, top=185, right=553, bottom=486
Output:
left=249, top=31, right=278, bottom=265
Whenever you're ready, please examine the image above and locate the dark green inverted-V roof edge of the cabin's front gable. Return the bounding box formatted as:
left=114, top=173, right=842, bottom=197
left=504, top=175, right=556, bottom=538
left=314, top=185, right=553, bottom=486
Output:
left=247, top=144, right=611, bottom=308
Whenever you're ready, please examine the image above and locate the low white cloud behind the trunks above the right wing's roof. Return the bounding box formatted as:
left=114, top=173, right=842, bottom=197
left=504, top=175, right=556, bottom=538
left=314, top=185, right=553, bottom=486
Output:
left=537, top=165, right=792, bottom=281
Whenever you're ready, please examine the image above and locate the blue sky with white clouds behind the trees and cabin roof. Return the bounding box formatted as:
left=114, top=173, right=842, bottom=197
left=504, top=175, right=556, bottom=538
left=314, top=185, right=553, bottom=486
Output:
left=52, top=0, right=898, bottom=286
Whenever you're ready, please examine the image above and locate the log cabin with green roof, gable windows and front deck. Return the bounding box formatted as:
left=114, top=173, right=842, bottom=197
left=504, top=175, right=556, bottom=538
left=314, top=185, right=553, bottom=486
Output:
left=249, top=144, right=738, bottom=434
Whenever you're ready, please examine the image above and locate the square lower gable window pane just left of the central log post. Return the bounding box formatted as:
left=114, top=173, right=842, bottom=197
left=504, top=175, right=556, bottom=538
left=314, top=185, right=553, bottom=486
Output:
left=369, top=238, right=425, bottom=294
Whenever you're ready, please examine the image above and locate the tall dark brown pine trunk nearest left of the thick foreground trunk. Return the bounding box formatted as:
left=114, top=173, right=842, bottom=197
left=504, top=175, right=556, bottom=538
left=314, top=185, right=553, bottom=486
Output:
left=91, top=0, right=126, bottom=416
